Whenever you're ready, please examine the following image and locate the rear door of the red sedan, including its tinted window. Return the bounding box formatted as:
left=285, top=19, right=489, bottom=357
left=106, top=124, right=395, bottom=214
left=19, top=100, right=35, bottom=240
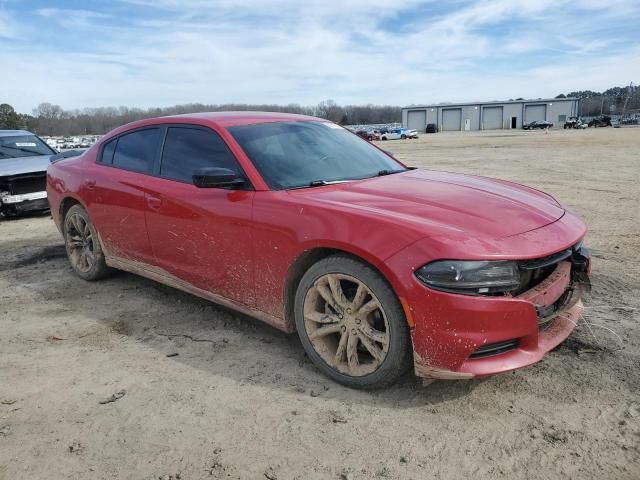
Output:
left=84, top=126, right=161, bottom=263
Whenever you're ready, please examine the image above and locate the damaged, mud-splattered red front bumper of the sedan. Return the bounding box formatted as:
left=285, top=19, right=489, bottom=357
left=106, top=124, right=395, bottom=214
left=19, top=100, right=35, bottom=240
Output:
left=400, top=248, right=590, bottom=379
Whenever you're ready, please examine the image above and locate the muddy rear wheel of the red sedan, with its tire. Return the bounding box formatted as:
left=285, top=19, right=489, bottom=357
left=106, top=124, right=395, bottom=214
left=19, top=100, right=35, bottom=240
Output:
left=64, top=205, right=112, bottom=280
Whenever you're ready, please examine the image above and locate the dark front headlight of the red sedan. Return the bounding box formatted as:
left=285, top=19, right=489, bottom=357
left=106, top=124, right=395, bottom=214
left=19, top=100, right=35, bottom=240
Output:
left=416, top=260, right=520, bottom=295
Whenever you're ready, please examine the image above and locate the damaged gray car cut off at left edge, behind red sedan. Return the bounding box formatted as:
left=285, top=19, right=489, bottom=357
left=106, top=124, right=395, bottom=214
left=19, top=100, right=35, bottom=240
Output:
left=0, top=130, right=57, bottom=217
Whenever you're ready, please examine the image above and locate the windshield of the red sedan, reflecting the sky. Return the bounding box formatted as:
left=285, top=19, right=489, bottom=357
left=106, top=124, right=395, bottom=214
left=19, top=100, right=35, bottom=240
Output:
left=228, top=122, right=406, bottom=190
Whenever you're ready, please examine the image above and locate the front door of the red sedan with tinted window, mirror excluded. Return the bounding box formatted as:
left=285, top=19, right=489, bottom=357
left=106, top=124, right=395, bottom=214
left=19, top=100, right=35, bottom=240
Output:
left=146, top=125, right=255, bottom=306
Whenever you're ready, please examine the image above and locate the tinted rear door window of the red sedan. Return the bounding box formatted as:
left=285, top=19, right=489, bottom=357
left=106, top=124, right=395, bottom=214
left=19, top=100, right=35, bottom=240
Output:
left=113, top=128, right=160, bottom=173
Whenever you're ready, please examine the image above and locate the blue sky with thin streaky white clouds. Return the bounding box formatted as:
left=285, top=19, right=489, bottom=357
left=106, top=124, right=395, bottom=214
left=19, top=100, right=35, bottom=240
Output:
left=0, top=0, right=640, bottom=113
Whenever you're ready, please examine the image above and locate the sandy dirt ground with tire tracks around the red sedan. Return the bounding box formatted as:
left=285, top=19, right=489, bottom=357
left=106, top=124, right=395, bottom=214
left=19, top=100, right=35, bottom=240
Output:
left=0, top=128, right=640, bottom=480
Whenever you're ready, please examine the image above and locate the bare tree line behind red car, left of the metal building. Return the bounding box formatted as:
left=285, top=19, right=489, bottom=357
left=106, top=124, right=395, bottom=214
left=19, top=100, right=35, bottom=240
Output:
left=0, top=100, right=402, bottom=136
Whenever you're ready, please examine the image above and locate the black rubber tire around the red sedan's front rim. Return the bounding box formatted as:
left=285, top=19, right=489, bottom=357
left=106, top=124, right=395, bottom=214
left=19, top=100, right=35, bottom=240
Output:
left=294, top=255, right=413, bottom=389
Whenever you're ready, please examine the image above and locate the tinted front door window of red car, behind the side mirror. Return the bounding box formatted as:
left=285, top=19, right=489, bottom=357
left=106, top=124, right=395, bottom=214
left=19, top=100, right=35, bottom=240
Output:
left=160, top=127, right=241, bottom=183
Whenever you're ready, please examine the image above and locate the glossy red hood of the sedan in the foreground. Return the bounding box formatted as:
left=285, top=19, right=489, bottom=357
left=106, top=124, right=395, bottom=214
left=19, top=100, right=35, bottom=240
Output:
left=301, top=170, right=564, bottom=238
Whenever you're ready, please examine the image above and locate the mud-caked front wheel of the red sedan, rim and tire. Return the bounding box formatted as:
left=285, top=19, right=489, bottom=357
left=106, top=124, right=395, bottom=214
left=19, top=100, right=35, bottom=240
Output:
left=295, top=255, right=411, bottom=388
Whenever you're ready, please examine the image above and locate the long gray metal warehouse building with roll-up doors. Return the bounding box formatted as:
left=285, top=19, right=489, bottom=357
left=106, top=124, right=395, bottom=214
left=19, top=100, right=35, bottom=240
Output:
left=402, top=98, right=579, bottom=132
